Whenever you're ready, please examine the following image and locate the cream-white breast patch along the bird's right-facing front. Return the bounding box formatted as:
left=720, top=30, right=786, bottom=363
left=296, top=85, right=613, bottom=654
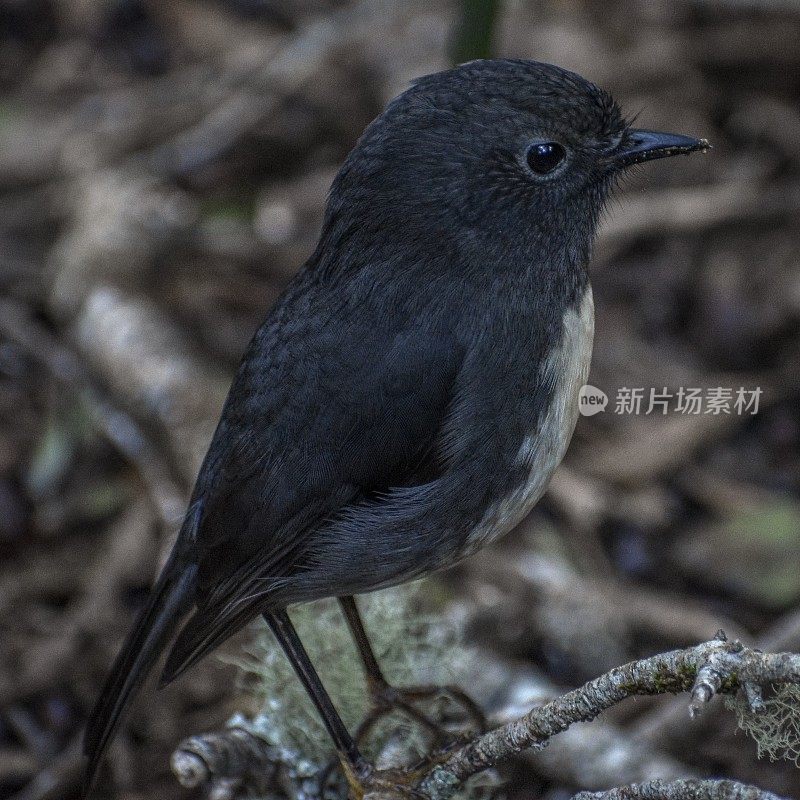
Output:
left=467, top=284, right=594, bottom=552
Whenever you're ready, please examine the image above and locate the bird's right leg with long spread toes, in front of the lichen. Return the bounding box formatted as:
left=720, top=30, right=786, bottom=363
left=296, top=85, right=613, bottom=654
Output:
left=339, top=596, right=486, bottom=744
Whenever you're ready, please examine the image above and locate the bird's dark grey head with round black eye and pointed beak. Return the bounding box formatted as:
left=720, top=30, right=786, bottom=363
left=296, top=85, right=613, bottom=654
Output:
left=318, top=60, right=708, bottom=272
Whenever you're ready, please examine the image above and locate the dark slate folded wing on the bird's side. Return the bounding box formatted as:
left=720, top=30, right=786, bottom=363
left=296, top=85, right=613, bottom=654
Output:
left=159, top=276, right=463, bottom=680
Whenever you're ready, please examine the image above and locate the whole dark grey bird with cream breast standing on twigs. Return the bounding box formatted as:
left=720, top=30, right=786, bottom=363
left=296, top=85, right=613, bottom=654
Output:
left=85, top=60, right=708, bottom=790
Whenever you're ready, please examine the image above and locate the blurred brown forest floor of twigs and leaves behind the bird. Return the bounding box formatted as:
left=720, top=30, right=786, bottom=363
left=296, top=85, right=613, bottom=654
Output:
left=0, top=0, right=800, bottom=800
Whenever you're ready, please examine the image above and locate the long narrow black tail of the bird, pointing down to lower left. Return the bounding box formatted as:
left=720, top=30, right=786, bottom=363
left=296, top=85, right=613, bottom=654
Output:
left=83, top=554, right=197, bottom=797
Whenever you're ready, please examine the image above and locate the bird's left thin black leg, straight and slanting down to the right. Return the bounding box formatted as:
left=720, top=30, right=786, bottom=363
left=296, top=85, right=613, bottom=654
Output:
left=263, top=611, right=370, bottom=777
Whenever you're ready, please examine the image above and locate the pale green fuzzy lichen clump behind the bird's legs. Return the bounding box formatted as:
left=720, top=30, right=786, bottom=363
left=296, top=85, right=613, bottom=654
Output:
left=222, top=580, right=475, bottom=765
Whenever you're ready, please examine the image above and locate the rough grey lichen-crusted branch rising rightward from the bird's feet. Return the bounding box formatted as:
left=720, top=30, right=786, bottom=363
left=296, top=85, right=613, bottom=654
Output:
left=419, top=633, right=800, bottom=800
